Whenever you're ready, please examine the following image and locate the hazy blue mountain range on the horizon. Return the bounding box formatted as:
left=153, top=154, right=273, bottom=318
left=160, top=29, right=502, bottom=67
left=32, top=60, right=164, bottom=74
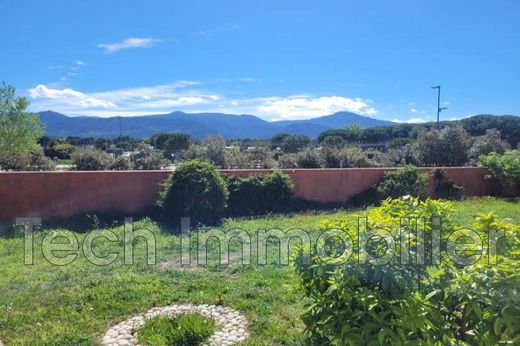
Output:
left=39, top=111, right=394, bottom=139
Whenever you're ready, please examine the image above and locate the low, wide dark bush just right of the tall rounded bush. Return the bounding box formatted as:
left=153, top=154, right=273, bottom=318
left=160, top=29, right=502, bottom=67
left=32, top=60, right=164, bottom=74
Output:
left=228, top=171, right=294, bottom=216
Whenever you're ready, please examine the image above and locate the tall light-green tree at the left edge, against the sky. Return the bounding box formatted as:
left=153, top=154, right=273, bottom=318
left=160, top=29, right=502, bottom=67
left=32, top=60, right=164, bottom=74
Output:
left=0, top=83, right=44, bottom=153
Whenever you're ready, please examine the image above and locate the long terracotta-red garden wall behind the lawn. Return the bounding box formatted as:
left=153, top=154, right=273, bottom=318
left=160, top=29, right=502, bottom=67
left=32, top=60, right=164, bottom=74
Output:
left=0, top=167, right=491, bottom=224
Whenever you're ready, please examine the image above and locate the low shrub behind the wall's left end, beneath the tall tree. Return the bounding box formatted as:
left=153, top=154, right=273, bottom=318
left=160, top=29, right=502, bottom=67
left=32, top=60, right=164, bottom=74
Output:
left=0, top=150, right=54, bottom=171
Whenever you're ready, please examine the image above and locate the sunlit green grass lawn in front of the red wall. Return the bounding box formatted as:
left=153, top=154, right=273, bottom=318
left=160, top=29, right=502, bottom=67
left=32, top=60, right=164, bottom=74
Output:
left=0, top=198, right=520, bottom=346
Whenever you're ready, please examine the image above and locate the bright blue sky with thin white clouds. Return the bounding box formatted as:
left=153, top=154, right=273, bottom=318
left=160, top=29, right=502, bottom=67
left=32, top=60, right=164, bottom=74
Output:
left=0, top=0, right=520, bottom=122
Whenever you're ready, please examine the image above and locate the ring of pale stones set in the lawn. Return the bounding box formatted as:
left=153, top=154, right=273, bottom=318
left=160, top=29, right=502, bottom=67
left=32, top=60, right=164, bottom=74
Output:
left=102, top=304, right=249, bottom=346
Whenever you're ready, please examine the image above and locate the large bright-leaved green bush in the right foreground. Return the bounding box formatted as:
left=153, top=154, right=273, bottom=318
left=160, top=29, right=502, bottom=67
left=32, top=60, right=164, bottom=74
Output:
left=295, top=198, right=520, bottom=345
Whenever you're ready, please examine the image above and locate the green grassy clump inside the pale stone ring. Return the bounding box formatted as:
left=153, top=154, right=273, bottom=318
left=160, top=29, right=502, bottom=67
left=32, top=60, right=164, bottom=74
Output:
left=137, top=314, right=215, bottom=346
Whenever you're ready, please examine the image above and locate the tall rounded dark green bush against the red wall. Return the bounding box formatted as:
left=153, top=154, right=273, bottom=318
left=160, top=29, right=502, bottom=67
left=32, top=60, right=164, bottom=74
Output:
left=159, top=160, right=229, bottom=225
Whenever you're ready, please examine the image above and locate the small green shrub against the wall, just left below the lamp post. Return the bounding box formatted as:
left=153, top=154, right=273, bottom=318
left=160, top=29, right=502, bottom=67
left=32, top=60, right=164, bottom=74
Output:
left=377, top=165, right=427, bottom=198
